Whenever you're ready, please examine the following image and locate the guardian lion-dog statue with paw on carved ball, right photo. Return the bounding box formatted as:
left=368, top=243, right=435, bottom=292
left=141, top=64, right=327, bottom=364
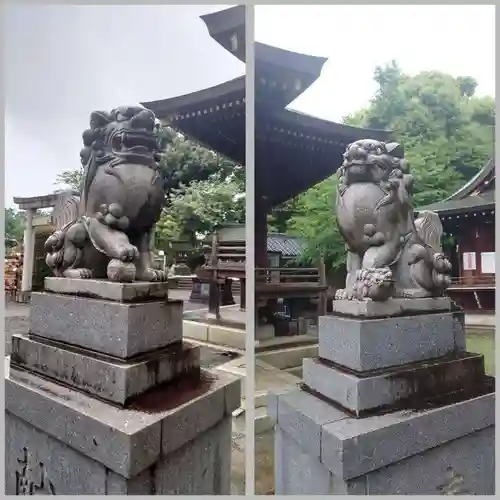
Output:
left=336, top=139, right=451, bottom=301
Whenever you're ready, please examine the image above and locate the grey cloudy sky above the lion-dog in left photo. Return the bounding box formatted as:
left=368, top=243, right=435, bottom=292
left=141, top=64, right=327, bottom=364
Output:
left=5, top=5, right=245, bottom=206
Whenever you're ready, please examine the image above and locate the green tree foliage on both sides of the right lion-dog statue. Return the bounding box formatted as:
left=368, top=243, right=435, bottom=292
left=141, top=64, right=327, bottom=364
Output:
left=287, top=62, right=495, bottom=268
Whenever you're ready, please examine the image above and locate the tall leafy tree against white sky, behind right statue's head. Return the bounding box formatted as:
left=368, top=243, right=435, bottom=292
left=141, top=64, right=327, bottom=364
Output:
left=344, top=61, right=495, bottom=180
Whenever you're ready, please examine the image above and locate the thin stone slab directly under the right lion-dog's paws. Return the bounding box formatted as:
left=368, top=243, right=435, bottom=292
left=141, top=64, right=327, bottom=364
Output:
left=333, top=297, right=452, bottom=318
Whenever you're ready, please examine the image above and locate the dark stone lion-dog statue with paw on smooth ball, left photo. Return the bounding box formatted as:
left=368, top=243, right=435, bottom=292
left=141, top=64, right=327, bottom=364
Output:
left=45, top=106, right=167, bottom=281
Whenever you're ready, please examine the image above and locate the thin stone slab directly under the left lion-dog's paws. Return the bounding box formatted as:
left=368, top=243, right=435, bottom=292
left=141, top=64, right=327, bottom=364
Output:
left=45, top=278, right=168, bottom=302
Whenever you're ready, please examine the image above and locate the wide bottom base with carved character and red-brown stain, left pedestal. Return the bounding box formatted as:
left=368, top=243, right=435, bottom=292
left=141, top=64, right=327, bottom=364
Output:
left=5, top=361, right=240, bottom=495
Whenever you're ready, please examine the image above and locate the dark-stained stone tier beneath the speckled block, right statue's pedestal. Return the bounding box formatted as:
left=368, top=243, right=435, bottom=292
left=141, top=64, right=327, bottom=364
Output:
left=302, top=354, right=484, bottom=415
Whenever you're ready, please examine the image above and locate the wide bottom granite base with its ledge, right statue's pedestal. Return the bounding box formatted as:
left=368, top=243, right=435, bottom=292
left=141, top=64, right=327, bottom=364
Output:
left=268, top=390, right=495, bottom=495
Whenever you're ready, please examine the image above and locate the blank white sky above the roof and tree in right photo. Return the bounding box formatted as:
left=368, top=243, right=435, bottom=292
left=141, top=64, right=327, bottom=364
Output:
left=255, top=5, right=495, bottom=121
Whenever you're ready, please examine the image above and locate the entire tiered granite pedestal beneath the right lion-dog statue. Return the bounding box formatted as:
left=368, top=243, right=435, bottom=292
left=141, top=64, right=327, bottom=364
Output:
left=269, top=299, right=495, bottom=495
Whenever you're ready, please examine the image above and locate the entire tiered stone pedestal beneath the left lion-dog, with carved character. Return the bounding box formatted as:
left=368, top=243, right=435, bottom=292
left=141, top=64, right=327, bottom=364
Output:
left=5, top=278, right=240, bottom=495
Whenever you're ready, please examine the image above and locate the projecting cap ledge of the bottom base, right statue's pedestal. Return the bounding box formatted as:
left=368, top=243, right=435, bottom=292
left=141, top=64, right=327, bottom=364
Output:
left=269, top=389, right=495, bottom=480
